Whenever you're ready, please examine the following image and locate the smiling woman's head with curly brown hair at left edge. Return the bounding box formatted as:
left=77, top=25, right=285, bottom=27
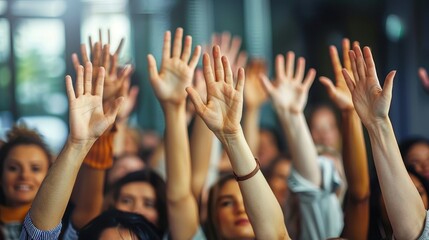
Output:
left=0, top=126, right=51, bottom=206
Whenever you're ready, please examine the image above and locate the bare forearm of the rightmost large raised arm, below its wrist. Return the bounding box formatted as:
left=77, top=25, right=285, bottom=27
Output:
left=367, top=118, right=426, bottom=239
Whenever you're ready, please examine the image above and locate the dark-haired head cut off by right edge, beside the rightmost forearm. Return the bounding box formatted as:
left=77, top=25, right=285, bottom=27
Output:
left=399, top=137, right=429, bottom=180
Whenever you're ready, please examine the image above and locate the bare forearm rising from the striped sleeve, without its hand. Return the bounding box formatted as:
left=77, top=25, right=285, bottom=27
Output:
left=30, top=140, right=94, bottom=230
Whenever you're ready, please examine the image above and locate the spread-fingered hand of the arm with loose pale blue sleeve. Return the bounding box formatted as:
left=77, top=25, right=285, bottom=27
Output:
left=261, top=52, right=316, bottom=113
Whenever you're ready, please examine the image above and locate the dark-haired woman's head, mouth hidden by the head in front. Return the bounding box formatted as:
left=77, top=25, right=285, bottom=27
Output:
left=113, top=169, right=168, bottom=231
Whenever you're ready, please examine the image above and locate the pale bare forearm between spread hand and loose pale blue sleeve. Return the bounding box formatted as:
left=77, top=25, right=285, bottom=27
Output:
left=277, top=110, right=322, bottom=186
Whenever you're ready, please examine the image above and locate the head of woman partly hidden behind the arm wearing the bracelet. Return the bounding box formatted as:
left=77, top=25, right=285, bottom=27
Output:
left=207, top=175, right=255, bottom=240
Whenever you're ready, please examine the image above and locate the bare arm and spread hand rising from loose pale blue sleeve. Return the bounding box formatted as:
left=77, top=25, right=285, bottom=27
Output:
left=261, top=52, right=322, bottom=186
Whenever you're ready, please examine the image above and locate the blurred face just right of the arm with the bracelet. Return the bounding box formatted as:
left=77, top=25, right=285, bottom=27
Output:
left=268, top=161, right=291, bottom=206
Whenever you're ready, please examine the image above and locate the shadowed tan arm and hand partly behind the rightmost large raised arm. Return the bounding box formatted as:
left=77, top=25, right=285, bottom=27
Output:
left=320, top=39, right=370, bottom=239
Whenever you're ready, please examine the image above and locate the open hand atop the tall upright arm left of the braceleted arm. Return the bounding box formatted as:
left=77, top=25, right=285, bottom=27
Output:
left=148, top=28, right=201, bottom=105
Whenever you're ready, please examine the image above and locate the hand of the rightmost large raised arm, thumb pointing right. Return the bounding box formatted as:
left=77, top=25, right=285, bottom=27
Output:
left=342, top=45, right=396, bottom=128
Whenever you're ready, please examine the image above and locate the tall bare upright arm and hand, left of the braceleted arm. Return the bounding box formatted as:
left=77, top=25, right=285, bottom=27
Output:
left=148, top=28, right=201, bottom=239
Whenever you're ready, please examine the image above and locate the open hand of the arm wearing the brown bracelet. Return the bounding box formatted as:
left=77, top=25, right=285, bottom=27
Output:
left=186, top=46, right=245, bottom=140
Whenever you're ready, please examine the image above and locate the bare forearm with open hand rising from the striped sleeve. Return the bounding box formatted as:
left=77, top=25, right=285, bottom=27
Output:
left=30, top=62, right=122, bottom=230
